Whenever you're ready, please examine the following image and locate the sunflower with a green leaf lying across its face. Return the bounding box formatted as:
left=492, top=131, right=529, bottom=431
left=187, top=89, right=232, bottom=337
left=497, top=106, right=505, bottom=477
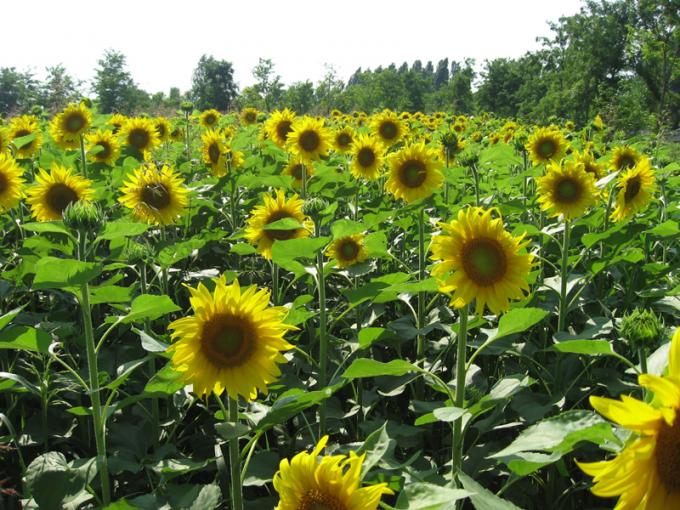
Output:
left=245, top=190, right=314, bottom=259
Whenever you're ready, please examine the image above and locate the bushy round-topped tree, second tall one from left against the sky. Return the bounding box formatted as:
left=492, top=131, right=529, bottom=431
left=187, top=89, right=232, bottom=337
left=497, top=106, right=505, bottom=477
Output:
left=191, top=55, right=237, bottom=111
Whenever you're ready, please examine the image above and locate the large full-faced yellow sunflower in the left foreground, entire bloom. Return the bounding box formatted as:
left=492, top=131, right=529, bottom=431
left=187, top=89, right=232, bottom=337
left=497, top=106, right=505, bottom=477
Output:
left=168, top=276, right=296, bottom=400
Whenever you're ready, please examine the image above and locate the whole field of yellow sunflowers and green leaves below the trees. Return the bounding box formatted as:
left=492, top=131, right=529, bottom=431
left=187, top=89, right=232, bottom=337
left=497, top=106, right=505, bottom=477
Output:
left=0, top=101, right=680, bottom=510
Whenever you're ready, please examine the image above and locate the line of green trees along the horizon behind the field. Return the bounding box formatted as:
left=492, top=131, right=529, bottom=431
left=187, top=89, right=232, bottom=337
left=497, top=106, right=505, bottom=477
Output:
left=0, top=0, right=680, bottom=131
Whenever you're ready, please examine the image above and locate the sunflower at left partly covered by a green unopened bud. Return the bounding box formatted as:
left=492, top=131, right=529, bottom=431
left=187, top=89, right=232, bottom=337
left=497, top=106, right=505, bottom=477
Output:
left=26, top=163, right=94, bottom=221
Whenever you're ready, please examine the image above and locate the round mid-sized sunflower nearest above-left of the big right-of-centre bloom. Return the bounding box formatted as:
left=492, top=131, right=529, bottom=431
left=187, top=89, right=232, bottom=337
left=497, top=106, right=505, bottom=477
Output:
left=385, top=142, right=444, bottom=203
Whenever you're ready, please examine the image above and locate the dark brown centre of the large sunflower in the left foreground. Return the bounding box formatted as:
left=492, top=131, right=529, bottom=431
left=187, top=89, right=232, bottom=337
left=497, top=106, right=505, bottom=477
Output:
left=201, top=315, right=254, bottom=368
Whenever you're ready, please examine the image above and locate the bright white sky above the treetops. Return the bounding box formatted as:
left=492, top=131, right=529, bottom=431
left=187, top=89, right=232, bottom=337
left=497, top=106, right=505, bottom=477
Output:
left=0, top=0, right=582, bottom=94
